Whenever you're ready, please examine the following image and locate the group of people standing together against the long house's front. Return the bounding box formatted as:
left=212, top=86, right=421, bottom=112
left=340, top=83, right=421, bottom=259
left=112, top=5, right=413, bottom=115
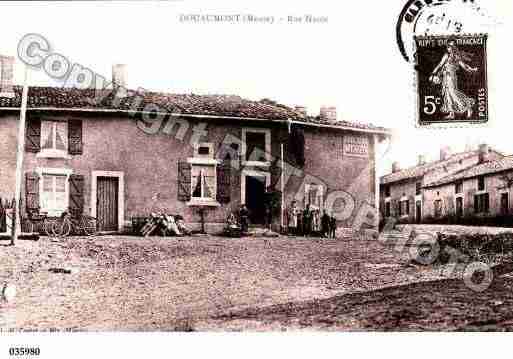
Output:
left=287, top=201, right=337, bottom=238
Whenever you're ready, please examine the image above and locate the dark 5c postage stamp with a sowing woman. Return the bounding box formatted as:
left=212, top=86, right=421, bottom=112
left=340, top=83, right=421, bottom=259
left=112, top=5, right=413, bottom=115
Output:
left=414, top=34, right=488, bottom=126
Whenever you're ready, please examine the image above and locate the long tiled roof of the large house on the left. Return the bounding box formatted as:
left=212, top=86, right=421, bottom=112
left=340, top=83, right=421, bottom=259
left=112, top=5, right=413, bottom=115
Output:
left=0, top=86, right=388, bottom=134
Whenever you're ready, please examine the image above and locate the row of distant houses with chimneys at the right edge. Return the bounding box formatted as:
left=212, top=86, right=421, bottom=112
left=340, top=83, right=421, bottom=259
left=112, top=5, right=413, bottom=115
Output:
left=380, top=144, right=513, bottom=223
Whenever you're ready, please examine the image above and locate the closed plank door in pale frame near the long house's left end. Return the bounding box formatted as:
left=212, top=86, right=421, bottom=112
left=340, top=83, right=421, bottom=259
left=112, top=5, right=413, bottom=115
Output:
left=96, top=177, right=119, bottom=231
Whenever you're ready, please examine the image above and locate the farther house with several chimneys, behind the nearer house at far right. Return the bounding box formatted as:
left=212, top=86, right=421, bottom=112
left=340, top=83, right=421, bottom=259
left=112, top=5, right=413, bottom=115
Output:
left=380, top=145, right=504, bottom=223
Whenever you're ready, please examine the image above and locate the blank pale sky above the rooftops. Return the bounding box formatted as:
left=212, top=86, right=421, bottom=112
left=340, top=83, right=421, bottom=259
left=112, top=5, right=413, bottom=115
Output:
left=0, top=0, right=513, bottom=174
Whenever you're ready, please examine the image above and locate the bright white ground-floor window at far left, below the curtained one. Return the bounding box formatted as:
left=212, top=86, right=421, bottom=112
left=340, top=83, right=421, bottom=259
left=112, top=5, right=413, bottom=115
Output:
left=40, top=173, right=68, bottom=216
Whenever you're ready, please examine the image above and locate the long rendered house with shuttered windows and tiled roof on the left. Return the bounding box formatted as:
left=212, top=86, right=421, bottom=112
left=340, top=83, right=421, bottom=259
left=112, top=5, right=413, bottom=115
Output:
left=0, top=56, right=389, bottom=232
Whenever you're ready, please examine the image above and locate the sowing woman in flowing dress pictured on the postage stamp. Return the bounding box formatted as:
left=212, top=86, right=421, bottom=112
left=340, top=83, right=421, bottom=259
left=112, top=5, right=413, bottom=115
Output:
left=429, top=41, right=478, bottom=119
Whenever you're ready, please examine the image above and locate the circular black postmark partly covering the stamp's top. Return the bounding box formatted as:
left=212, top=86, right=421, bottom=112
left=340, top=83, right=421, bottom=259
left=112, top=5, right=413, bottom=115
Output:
left=396, top=0, right=498, bottom=62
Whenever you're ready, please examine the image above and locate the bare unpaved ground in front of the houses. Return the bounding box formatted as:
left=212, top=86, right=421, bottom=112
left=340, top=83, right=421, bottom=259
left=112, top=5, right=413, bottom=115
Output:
left=0, top=236, right=504, bottom=330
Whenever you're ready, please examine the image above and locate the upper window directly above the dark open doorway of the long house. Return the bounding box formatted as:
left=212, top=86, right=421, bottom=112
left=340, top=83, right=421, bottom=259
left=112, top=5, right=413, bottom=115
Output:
left=242, top=128, right=271, bottom=166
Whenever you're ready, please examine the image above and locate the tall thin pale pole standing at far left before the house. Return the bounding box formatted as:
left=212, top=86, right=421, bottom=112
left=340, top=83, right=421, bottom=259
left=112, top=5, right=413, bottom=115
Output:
left=11, top=66, right=28, bottom=245
